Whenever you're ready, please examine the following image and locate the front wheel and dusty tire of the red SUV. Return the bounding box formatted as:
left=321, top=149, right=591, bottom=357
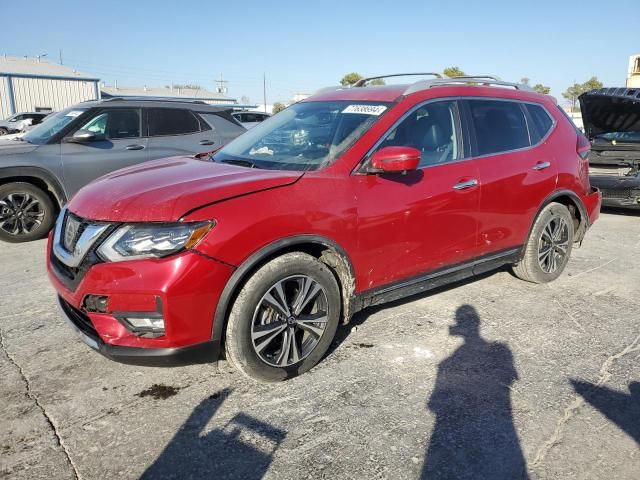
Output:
left=225, top=252, right=341, bottom=382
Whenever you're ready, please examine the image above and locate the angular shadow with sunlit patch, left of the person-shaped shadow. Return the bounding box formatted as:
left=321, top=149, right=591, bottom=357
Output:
left=141, top=389, right=286, bottom=480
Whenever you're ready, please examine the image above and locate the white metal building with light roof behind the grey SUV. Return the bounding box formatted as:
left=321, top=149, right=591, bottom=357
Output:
left=0, top=55, right=100, bottom=118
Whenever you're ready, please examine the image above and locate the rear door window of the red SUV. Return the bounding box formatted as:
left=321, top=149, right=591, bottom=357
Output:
left=468, top=100, right=531, bottom=155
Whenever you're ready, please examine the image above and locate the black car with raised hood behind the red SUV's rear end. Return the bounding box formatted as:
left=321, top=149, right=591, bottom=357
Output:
left=579, top=88, right=640, bottom=208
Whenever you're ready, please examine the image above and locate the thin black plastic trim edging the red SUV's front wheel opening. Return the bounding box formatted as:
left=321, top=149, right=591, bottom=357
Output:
left=211, top=234, right=355, bottom=344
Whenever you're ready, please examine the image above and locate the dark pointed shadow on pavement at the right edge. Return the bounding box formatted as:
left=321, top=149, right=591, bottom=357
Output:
left=571, top=380, right=640, bottom=443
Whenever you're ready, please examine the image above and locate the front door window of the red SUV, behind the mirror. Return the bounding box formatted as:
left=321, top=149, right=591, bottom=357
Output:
left=378, top=101, right=461, bottom=167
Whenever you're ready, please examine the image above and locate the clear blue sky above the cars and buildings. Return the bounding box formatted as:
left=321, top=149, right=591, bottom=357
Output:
left=0, top=0, right=640, bottom=103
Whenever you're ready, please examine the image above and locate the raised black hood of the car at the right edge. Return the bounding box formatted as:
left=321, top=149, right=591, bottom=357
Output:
left=578, top=88, right=640, bottom=140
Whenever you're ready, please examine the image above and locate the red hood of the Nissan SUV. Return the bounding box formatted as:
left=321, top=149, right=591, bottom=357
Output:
left=69, top=157, right=303, bottom=222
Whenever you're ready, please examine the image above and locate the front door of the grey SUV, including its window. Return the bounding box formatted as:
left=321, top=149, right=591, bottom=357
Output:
left=60, top=108, right=149, bottom=195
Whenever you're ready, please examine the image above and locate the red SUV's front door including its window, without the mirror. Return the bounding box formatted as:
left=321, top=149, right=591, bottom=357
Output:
left=352, top=101, right=480, bottom=290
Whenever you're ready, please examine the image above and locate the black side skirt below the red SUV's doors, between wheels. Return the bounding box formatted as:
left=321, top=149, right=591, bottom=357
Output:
left=353, top=247, right=522, bottom=313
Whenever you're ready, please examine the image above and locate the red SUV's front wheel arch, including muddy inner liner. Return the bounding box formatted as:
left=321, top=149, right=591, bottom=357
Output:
left=211, top=235, right=355, bottom=351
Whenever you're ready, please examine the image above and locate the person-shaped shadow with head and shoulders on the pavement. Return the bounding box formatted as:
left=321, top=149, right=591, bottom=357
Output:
left=422, top=305, right=528, bottom=480
